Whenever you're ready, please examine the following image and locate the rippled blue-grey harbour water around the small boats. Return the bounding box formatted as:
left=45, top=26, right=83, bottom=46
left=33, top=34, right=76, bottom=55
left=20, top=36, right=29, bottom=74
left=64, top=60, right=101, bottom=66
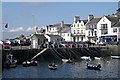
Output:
left=3, top=58, right=120, bottom=78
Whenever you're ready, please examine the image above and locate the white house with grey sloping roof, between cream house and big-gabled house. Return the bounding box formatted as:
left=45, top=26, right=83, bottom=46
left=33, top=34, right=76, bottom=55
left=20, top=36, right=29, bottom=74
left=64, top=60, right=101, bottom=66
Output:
left=85, top=15, right=101, bottom=43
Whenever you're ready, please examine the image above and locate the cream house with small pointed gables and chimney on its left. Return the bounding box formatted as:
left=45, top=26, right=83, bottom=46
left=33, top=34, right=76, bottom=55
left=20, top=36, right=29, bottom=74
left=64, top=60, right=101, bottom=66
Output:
left=71, top=16, right=87, bottom=42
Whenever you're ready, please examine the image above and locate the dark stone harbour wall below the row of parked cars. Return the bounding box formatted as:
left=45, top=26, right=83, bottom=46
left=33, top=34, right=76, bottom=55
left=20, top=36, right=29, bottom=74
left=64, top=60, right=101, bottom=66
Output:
left=2, top=47, right=114, bottom=63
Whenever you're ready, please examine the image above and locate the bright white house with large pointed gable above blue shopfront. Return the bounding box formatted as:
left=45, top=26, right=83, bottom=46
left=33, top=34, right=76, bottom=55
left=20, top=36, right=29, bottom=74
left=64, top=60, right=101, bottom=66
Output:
left=97, top=16, right=120, bottom=43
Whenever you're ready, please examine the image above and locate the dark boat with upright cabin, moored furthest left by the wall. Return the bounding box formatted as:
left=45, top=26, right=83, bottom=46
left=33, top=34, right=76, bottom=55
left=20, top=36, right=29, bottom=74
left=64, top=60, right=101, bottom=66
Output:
left=4, top=54, right=17, bottom=68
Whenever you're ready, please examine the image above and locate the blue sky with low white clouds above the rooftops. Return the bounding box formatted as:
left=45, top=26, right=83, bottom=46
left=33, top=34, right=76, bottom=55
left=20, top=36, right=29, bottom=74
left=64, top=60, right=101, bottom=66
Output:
left=2, top=2, right=118, bottom=39
